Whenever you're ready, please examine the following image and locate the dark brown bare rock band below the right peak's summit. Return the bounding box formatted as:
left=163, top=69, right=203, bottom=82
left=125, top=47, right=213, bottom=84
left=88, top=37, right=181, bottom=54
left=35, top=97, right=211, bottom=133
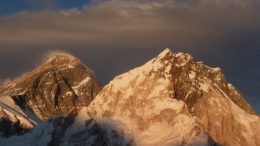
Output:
left=168, top=51, right=254, bottom=114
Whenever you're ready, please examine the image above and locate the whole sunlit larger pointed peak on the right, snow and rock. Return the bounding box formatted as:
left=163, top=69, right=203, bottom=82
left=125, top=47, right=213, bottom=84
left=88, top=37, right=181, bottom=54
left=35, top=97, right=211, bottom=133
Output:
left=89, top=49, right=260, bottom=146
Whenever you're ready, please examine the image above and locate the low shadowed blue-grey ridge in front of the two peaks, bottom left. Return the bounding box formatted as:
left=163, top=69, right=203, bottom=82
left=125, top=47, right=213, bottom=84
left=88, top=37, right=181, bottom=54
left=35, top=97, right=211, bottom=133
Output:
left=0, top=108, right=110, bottom=146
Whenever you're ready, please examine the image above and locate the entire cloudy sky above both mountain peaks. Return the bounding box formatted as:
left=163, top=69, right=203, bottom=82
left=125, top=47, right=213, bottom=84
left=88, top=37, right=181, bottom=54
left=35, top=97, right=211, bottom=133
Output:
left=0, top=0, right=260, bottom=113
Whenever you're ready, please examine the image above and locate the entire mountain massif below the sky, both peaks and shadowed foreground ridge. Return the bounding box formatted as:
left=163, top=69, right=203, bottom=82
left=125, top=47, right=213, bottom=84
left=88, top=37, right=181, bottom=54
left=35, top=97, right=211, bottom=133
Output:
left=0, top=49, right=260, bottom=146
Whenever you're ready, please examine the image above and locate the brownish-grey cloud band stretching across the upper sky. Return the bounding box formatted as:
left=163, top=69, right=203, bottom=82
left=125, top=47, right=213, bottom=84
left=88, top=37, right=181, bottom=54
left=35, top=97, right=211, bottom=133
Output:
left=0, top=0, right=260, bottom=48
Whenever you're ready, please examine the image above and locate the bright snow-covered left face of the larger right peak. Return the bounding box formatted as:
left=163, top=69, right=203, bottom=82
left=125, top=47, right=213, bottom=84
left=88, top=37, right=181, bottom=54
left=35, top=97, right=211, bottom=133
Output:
left=88, top=49, right=221, bottom=146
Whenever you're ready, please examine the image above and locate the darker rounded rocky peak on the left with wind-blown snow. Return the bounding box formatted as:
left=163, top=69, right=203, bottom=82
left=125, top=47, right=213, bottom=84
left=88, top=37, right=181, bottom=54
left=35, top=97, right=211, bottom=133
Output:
left=0, top=53, right=101, bottom=137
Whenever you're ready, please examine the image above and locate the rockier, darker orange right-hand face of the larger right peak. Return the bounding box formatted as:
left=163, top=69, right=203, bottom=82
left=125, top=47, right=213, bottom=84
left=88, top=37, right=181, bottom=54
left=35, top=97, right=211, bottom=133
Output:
left=160, top=50, right=260, bottom=146
